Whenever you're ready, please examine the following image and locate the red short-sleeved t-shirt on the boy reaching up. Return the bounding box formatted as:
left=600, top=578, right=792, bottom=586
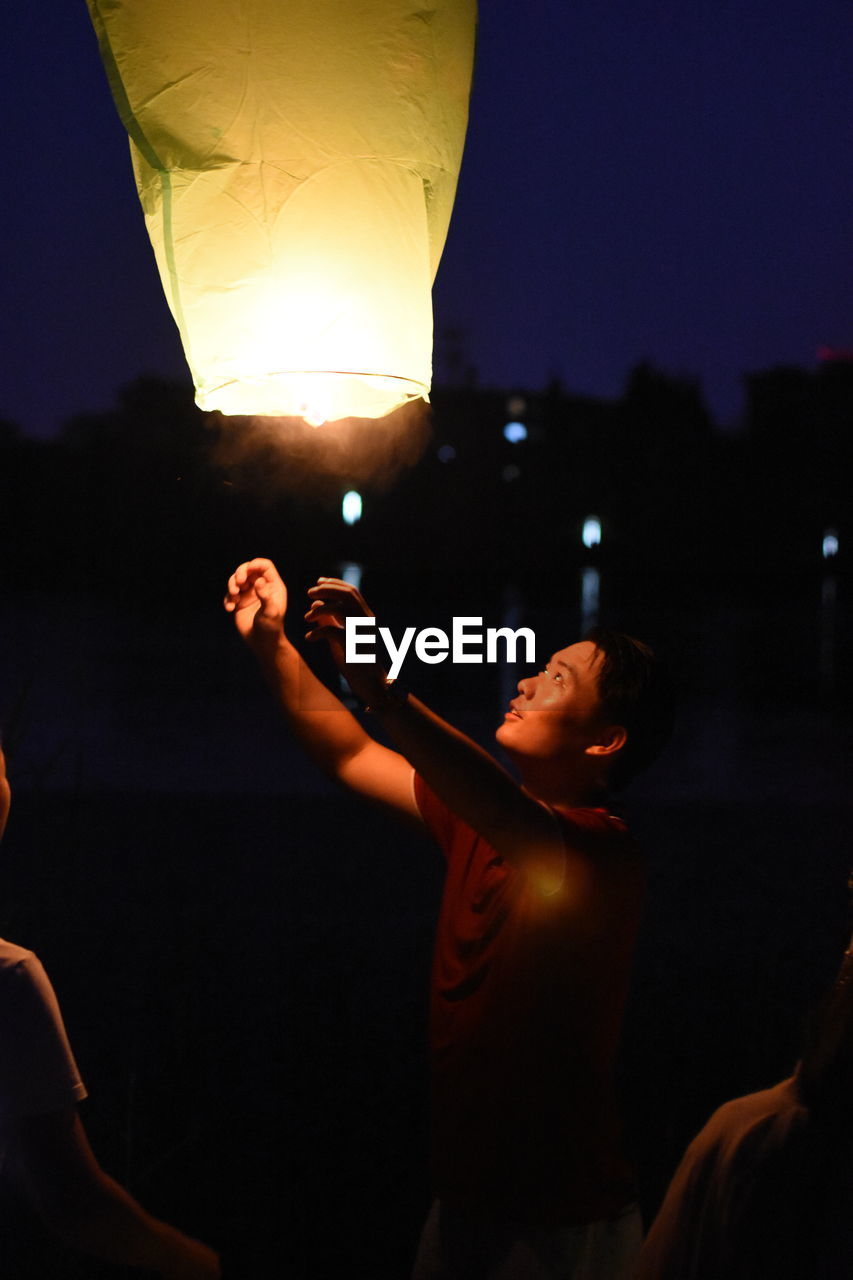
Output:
left=415, top=776, right=646, bottom=1225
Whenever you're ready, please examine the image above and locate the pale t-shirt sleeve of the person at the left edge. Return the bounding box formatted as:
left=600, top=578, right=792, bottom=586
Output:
left=0, top=942, right=86, bottom=1125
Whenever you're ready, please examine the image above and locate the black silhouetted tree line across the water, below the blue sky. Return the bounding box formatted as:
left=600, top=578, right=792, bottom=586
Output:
left=0, top=362, right=853, bottom=608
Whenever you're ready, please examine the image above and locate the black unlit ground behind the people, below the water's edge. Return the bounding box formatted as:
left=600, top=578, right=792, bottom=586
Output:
left=3, top=795, right=849, bottom=1280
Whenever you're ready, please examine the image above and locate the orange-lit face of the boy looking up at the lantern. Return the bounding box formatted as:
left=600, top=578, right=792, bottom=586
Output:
left=496, top=640, right=603, bottom=759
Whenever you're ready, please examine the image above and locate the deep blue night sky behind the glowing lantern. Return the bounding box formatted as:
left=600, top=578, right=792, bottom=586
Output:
left=0, top=0, right=853, bottom=434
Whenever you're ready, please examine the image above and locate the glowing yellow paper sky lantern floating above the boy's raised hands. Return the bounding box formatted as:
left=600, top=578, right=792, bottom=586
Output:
left=88, top=0, right=475, bottom=424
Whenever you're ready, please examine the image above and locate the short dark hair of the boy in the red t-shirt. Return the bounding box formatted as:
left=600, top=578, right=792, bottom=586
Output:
left=585, top=627, right=675, bottom=788
